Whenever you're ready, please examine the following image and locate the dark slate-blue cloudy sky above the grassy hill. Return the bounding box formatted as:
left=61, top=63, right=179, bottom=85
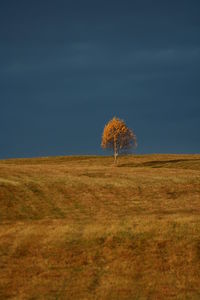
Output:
left=0, top=0, right=200, bottom=159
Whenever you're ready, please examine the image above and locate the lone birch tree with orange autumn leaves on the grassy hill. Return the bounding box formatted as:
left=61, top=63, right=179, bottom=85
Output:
left=101, top=117, right=137, bottom=163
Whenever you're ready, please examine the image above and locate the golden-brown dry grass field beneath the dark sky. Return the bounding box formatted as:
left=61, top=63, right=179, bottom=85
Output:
left=0, top=155, right=200, bottom=300
